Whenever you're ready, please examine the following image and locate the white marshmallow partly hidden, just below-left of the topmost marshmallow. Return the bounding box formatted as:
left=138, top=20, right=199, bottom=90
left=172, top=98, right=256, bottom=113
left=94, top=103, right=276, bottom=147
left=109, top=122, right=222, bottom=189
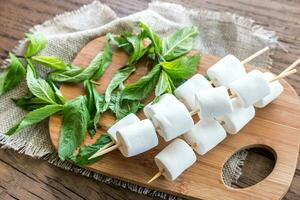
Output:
left=174, top=74, right=212, bottom=111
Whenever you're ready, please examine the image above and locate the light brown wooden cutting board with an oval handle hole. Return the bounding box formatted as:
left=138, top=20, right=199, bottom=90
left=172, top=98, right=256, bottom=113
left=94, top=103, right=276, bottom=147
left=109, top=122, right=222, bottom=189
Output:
left=49, top=37, right=300, bottom=200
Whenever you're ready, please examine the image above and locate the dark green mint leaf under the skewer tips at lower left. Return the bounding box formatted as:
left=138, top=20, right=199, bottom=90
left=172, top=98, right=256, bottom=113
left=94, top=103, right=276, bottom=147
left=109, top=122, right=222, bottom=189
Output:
left=70, top=134, right=111, bottom=166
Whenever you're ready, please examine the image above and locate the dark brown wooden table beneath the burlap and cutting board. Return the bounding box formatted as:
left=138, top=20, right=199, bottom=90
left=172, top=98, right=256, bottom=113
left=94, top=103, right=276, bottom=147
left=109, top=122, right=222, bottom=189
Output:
left=0, top=0, right=300, bottom=200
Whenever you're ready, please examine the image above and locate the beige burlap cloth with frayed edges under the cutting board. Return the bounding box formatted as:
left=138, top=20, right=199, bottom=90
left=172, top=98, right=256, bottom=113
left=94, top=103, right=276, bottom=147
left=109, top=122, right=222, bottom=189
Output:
left=0, top=1, right=277, bottom=199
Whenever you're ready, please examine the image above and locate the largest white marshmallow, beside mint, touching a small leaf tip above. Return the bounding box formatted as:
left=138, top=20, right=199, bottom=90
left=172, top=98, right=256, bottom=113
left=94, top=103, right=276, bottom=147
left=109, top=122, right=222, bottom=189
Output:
left=144, top=94, right=194, bottom=142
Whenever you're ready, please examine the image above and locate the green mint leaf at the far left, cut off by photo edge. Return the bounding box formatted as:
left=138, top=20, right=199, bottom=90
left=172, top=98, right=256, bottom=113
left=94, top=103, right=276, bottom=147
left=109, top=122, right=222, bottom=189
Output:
left=0, top=53, right=26, bottom=95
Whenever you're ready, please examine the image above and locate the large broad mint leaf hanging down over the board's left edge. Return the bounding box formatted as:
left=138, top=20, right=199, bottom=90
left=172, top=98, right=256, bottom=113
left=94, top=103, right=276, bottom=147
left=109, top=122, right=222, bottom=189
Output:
left=58, top=96, right=89, bottom=160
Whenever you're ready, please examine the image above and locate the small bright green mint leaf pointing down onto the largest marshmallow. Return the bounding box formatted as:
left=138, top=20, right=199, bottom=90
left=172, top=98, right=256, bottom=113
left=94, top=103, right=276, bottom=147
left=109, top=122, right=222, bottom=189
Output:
left=155, top=70, right=175, bottom=97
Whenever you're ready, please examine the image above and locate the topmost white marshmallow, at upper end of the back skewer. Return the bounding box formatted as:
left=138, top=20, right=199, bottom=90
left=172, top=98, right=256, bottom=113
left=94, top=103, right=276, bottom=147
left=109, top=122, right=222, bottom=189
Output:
left=207, top=55, right=246, bottom=88
